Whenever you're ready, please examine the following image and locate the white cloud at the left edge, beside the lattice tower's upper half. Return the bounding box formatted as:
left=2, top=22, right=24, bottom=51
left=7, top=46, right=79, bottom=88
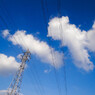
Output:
left=0, top=54, right=20, bottom=75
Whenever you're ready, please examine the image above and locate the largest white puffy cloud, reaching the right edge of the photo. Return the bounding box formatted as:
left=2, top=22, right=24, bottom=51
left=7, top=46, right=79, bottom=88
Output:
left=47, top=16, right=95, bottom=71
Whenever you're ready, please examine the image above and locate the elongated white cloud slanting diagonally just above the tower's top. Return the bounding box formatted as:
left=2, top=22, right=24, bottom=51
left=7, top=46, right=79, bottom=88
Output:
left=2, top=30, right=63, bottom=68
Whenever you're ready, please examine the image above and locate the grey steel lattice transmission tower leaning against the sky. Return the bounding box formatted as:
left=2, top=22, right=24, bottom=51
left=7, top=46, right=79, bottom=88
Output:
left=8, top=50, right=31, bottom=95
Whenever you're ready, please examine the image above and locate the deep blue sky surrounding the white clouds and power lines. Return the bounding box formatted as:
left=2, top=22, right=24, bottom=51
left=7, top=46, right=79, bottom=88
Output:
left=0, top=0, right=95, bottom=95
